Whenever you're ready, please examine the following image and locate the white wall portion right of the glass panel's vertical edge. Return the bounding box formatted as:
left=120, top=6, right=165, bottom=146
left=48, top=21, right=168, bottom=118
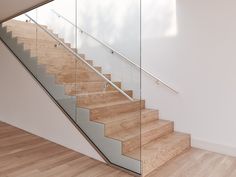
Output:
left=142, top=0, right=236, bottom=155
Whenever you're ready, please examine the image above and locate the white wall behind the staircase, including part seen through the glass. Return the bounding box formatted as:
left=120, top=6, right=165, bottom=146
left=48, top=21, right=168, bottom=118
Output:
left=11, top=0, right=236, bottom=155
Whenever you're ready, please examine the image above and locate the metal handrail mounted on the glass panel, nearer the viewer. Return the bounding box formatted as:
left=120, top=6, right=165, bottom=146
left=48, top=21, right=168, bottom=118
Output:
left=25, top=14, right=134, bottom=101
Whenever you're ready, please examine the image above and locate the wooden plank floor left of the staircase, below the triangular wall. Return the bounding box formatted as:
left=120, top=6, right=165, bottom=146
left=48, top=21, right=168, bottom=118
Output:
left=0, top=122, right=130, bottom=177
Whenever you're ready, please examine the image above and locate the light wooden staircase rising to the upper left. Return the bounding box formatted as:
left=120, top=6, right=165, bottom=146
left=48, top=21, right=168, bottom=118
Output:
left=0, top=20, right=190, bottom=176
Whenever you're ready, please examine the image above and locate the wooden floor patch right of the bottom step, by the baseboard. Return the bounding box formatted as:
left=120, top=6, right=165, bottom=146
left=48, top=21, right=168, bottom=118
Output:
left=148, top=148, right=236, bottom=177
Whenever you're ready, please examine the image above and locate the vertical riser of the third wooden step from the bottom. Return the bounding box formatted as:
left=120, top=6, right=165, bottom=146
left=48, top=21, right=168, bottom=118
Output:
left=105, top=111, right=159, bottom=136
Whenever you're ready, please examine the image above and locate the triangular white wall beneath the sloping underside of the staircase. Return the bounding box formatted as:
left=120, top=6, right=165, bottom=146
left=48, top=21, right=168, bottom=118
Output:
left=0, top=42, right=103, bottom=161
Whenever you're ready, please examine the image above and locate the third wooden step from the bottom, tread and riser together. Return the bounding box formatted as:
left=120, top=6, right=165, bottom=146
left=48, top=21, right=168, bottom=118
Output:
left=94, top=109, right=159, bottom=136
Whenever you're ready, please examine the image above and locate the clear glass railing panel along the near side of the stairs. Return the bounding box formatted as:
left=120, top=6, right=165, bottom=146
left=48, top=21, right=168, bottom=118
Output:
left=0, top=1, right=141, bottom=174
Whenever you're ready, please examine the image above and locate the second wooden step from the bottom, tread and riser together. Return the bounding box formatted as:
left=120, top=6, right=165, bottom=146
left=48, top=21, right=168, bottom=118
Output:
left=108, top=120, right=174, bottom=154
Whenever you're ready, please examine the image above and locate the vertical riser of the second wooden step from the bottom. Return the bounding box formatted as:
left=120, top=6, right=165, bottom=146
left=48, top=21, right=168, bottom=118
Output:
left=122, top=123, right=174, bottom=154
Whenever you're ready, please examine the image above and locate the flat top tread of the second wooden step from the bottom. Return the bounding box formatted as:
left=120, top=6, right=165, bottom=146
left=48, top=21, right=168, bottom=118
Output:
left=109, top=120, right=171, bottom=141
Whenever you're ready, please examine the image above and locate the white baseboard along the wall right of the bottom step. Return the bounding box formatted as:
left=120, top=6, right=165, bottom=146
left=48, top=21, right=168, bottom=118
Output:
left=191, top=138, right=236, bottom=157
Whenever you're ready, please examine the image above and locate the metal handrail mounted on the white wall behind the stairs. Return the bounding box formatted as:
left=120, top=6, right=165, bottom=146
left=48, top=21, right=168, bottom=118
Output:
left=51, top=9, right=179, bottom=94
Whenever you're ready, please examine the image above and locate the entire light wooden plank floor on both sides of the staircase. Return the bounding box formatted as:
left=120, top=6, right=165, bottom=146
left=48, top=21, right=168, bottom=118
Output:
left=0, top=122, right=236, bottom=177
